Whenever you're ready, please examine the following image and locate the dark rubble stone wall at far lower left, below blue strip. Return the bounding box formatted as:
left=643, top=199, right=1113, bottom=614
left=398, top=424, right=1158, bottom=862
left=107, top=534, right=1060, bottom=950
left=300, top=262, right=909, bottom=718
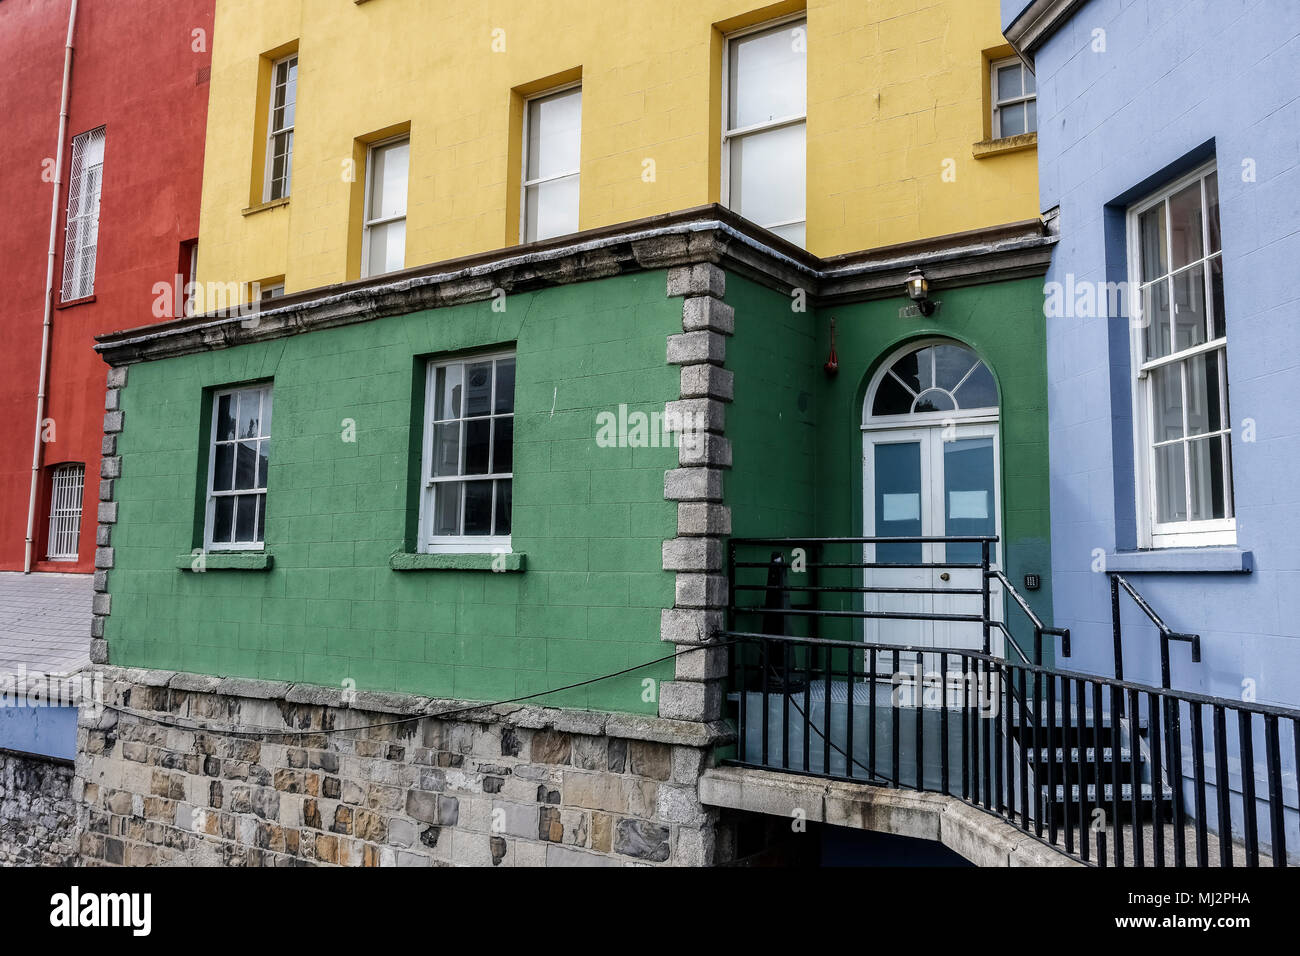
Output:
left=0, top=750, right=77, bottom=866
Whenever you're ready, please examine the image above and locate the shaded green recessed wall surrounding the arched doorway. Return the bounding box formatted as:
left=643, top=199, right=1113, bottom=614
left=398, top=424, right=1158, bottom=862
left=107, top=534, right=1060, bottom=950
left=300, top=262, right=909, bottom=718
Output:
left=727, top=276, right=1052, bottom=659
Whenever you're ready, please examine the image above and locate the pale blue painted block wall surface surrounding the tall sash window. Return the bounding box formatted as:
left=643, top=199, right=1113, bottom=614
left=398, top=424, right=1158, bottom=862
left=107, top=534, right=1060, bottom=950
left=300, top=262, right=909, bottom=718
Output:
left=1019, top=0, right=1300, bottom=707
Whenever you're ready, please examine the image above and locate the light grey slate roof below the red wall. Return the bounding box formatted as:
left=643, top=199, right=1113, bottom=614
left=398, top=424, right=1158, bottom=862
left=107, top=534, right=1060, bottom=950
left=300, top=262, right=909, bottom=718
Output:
left=0, top=571, right=94, bottom=674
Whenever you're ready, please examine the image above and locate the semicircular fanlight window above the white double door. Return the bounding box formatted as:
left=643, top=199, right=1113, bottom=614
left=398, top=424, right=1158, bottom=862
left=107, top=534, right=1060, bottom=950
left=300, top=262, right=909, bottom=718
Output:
left=868, top=342, right=997, bottom=418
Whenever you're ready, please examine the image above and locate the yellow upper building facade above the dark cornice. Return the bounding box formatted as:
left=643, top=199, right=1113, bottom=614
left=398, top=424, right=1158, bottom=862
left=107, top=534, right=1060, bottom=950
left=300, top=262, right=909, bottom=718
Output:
left=198, top=0, right=1037, bottom=293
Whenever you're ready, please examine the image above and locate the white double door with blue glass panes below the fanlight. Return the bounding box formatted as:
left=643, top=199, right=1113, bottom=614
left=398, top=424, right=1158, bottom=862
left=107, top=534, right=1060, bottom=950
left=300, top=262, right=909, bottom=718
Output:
left=863, top=421, right=1002, bottom=658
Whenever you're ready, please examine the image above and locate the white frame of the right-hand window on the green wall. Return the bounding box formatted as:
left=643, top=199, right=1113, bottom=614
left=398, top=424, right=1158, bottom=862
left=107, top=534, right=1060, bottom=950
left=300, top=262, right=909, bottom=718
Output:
left=416, top=350, right=519, bottom=554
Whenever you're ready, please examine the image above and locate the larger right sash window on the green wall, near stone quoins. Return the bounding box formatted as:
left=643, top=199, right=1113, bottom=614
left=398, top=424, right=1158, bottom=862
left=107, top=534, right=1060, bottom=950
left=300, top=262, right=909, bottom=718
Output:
left=420, top=354, right=515, bottom=553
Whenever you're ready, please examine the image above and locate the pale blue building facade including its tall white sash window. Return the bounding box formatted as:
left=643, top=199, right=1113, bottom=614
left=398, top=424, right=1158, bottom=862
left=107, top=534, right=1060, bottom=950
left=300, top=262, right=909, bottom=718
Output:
left=1002, top=0, right=1300, bottom=858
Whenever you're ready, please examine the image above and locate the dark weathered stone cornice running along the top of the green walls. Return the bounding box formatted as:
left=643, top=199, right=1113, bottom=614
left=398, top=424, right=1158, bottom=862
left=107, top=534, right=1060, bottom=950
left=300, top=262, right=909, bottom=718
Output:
left=95, top=204, right=1057, bottom=367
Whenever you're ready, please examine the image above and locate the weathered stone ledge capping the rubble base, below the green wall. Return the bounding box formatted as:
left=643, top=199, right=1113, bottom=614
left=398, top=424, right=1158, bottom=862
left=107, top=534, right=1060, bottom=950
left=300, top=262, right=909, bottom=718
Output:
left=94, top=666, right=735, bottom=747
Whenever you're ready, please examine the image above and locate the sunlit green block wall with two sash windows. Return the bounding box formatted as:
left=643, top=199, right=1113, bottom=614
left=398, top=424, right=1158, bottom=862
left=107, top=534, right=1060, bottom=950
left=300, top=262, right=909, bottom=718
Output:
left=105, top=272, right=681, bottom=713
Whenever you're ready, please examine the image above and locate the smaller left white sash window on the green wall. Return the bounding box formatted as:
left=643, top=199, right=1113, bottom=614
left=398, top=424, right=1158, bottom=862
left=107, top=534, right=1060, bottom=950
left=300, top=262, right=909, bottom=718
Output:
left=204, top=385, right=270, bottom=551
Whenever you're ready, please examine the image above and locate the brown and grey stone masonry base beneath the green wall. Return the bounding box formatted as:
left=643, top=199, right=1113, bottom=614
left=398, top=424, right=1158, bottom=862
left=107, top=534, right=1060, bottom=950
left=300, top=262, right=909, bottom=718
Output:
left=73, top=667, right=727, bottom=866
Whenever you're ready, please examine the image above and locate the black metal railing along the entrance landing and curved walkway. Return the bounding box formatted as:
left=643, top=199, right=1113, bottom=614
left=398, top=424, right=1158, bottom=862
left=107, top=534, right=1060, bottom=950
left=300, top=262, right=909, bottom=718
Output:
left=727, top=538, right=1300, bottom=866
